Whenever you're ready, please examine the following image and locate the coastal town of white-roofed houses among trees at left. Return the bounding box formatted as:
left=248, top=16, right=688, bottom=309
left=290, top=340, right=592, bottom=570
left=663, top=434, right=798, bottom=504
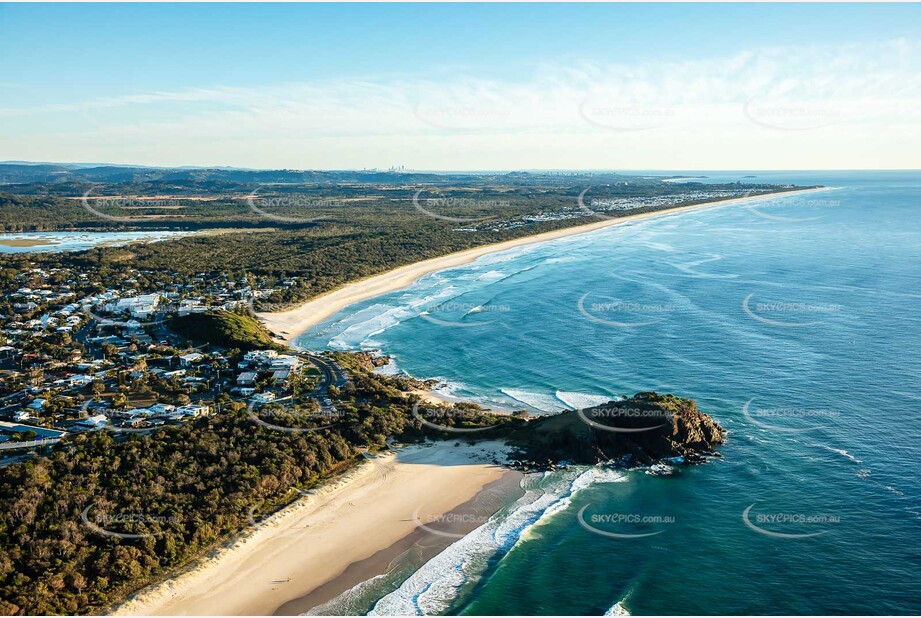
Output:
left=0, top=267, right=346, bottom=466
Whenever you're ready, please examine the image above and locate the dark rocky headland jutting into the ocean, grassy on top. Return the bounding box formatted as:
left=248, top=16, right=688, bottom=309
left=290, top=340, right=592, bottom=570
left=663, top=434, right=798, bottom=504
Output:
left=510, top=393, right=726, bottom=464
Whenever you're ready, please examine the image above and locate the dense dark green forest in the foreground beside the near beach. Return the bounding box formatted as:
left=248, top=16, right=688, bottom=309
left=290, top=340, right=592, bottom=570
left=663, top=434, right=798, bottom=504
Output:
left=0, top=354, right=518, bottom=615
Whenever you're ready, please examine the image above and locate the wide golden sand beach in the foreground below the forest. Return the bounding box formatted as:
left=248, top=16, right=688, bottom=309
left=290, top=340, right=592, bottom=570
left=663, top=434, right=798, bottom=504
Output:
left=114, top=442, right=518, bottom=616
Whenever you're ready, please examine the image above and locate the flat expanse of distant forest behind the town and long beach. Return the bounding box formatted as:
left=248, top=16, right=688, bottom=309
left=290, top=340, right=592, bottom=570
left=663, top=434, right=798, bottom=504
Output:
left=0, top=166, right=804, bottom=310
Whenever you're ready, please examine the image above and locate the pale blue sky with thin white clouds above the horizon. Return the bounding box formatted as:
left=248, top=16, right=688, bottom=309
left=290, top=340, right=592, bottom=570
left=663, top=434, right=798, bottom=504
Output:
left=0, top=4, right=921, bottom=170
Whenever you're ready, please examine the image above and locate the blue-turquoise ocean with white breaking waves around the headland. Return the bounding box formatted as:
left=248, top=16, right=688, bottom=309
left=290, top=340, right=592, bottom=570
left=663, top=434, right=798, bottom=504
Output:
left=299, top=172, right=921, bottom=615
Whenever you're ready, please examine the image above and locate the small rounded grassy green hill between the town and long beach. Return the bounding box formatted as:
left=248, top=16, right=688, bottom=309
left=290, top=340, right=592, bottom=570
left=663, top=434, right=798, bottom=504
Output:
left=169, top=311, right=282, bottom=351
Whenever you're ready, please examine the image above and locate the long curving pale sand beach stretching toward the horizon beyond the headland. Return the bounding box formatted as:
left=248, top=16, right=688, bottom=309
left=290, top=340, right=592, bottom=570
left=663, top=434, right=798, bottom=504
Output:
left=259, top=187, right=827, bottom=345
